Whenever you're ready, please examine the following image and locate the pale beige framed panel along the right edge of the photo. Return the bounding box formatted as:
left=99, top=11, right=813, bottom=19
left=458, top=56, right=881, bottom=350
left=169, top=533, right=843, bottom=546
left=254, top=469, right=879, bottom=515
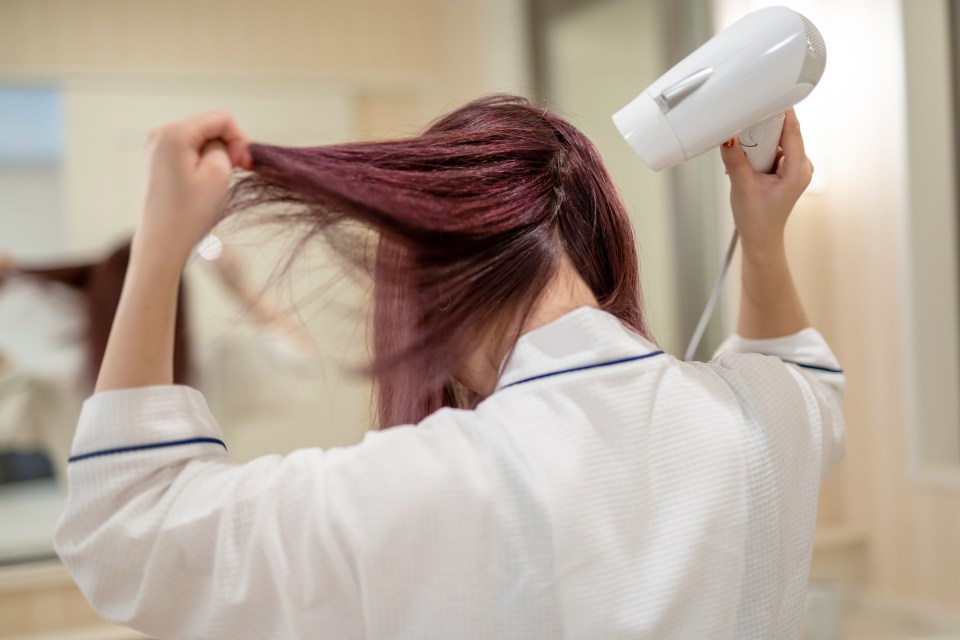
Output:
left=901, top=0, right=960, bottom=476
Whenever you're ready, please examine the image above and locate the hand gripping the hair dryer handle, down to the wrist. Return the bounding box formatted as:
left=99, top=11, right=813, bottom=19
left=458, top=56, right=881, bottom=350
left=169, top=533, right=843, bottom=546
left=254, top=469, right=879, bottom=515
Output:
left=720, top=109, right=813, bottom=254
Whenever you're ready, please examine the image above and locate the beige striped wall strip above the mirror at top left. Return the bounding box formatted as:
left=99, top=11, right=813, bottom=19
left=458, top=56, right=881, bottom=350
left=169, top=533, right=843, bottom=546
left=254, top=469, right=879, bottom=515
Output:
left=0, top=0, right=512, bottom=102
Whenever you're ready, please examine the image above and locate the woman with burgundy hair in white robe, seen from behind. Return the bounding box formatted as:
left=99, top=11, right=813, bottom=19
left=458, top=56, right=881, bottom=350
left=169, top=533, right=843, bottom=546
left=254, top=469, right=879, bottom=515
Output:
left=56, top=97, right=844, bottom=639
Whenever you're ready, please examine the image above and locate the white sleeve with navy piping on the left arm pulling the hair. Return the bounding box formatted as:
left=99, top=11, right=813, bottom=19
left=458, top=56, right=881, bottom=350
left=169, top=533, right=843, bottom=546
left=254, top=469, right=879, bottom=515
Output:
left=55, top=386, right=363, bottom=639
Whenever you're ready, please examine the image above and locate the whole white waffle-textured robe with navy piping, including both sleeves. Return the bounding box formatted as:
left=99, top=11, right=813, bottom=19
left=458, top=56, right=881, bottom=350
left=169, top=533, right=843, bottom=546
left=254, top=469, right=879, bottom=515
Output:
left=56, top=308, right=844, bottom=640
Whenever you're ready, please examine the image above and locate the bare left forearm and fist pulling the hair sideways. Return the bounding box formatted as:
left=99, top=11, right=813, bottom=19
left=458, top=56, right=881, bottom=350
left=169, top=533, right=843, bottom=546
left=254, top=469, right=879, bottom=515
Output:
left=96, top=112, right=251, bottom=392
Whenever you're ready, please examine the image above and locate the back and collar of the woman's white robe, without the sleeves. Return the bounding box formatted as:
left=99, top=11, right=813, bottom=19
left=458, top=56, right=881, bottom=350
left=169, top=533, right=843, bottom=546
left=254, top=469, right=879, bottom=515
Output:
left=336, top=308, right=842, bottom=638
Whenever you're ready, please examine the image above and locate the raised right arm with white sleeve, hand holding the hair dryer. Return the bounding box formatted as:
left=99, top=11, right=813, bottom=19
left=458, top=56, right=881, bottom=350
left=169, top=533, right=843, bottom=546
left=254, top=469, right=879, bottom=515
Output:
left=717, top=110, right=846, bottom=480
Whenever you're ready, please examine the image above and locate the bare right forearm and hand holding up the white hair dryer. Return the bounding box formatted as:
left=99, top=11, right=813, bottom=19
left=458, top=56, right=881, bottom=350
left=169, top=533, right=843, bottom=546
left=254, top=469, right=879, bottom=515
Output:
left=721, top=109, right=813, bottom=338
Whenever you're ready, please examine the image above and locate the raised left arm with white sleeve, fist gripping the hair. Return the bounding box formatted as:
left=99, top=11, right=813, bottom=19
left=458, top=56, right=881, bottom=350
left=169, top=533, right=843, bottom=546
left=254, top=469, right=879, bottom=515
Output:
left=54, top=113, right=378, bottom=640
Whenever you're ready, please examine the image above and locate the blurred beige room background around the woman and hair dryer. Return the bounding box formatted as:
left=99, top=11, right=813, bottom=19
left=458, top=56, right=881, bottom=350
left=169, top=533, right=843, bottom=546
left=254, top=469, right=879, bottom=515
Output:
left=0, top=0, right=960, bottom=640
